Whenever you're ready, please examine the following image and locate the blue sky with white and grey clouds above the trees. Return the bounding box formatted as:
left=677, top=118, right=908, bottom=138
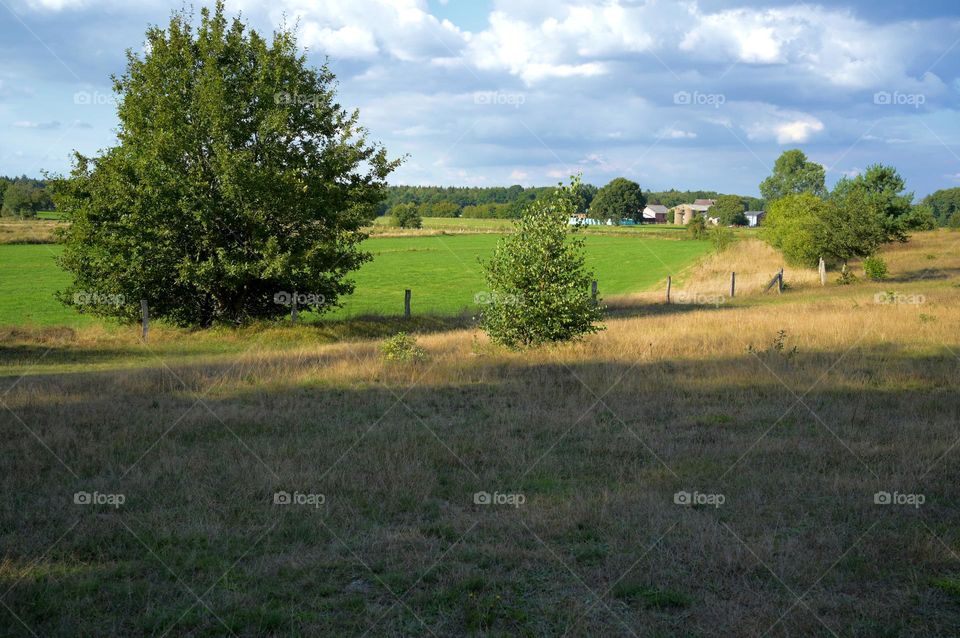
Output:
left=0, top=0, right=960, bottom=196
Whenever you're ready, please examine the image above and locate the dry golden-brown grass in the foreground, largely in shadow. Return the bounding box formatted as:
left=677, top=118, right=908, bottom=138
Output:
left=0, top=232, right=960, bottom=638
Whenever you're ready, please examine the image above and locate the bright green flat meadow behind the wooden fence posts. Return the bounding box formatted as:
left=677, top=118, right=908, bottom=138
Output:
left=0, top=234, right=709, bottom=326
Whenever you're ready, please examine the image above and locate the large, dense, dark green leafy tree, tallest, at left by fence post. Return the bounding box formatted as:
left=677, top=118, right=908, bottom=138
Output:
left=57, top=2, right=398, bottom=326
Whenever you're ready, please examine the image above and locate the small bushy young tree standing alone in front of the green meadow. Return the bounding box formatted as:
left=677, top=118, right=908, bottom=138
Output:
left=480, top=179, right=603, bottom=348
